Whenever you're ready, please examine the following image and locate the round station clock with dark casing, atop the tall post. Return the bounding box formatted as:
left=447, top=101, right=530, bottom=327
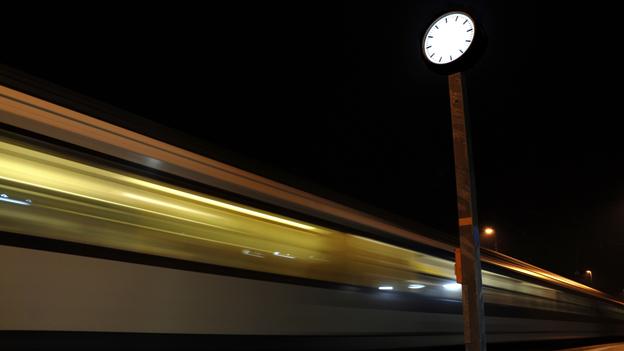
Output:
left=422, top=11, right=484, bottom=73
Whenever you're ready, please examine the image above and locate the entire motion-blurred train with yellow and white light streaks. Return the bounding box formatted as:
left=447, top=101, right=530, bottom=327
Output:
left=0, top=73, right=624, bottom=349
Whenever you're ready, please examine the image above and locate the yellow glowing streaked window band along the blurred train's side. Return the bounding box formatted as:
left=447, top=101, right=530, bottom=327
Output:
left=0, top=138, right=620, bottom=322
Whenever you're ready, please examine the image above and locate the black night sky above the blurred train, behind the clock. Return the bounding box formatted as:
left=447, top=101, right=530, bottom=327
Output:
left=5, top=0, right=624, bottom=293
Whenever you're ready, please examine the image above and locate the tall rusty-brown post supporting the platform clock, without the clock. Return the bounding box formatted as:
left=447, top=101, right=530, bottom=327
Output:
left=448, top=72, right=486, bottom=351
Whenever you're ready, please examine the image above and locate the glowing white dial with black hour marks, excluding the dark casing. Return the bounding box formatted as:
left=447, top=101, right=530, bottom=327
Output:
left=423, top=12, right=475, bottom=65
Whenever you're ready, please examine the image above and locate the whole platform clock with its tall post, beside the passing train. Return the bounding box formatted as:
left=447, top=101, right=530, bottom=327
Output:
left=422, top=11, right=487, bottom=351
